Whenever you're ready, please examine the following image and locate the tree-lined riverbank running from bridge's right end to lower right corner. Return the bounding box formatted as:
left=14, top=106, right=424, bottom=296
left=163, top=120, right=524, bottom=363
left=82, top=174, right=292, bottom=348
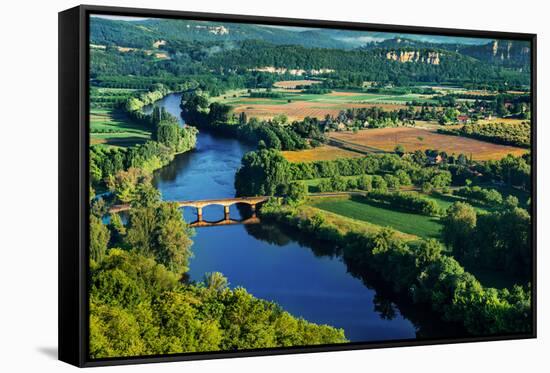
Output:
left=260, top=201, right=531, bottom=335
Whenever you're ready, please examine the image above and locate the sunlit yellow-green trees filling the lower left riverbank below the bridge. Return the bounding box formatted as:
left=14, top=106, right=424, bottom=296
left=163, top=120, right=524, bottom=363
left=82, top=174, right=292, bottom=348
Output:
left=90, top=182, right=346, bottom=358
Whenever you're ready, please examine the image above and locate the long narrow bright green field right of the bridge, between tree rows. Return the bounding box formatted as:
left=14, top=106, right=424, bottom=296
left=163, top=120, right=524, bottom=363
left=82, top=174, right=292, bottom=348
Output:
left=313, top=199, right=441, bottom=238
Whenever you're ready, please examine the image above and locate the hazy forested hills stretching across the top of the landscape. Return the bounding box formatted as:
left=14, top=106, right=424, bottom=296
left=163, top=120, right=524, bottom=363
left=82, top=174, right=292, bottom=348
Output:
left=91, top=18, right=529, bottom=88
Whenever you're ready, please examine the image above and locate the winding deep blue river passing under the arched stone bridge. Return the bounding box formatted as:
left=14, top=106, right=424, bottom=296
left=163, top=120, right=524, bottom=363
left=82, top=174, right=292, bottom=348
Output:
left=144, top=94, right=442, bottom=342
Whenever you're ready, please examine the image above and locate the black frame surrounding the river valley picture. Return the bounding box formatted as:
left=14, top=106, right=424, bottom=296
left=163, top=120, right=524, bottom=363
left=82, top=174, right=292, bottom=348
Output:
left=58, top=5, right=537, bottom=367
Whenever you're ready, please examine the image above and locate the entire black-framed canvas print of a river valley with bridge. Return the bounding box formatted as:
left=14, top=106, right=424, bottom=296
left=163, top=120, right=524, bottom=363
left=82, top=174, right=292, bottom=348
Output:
left=59, top=6, right=537, bottom=367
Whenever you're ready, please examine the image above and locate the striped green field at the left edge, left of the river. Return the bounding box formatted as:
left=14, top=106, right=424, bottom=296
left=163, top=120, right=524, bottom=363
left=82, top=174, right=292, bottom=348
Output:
left=90, top=109, right=151, bottom=147
